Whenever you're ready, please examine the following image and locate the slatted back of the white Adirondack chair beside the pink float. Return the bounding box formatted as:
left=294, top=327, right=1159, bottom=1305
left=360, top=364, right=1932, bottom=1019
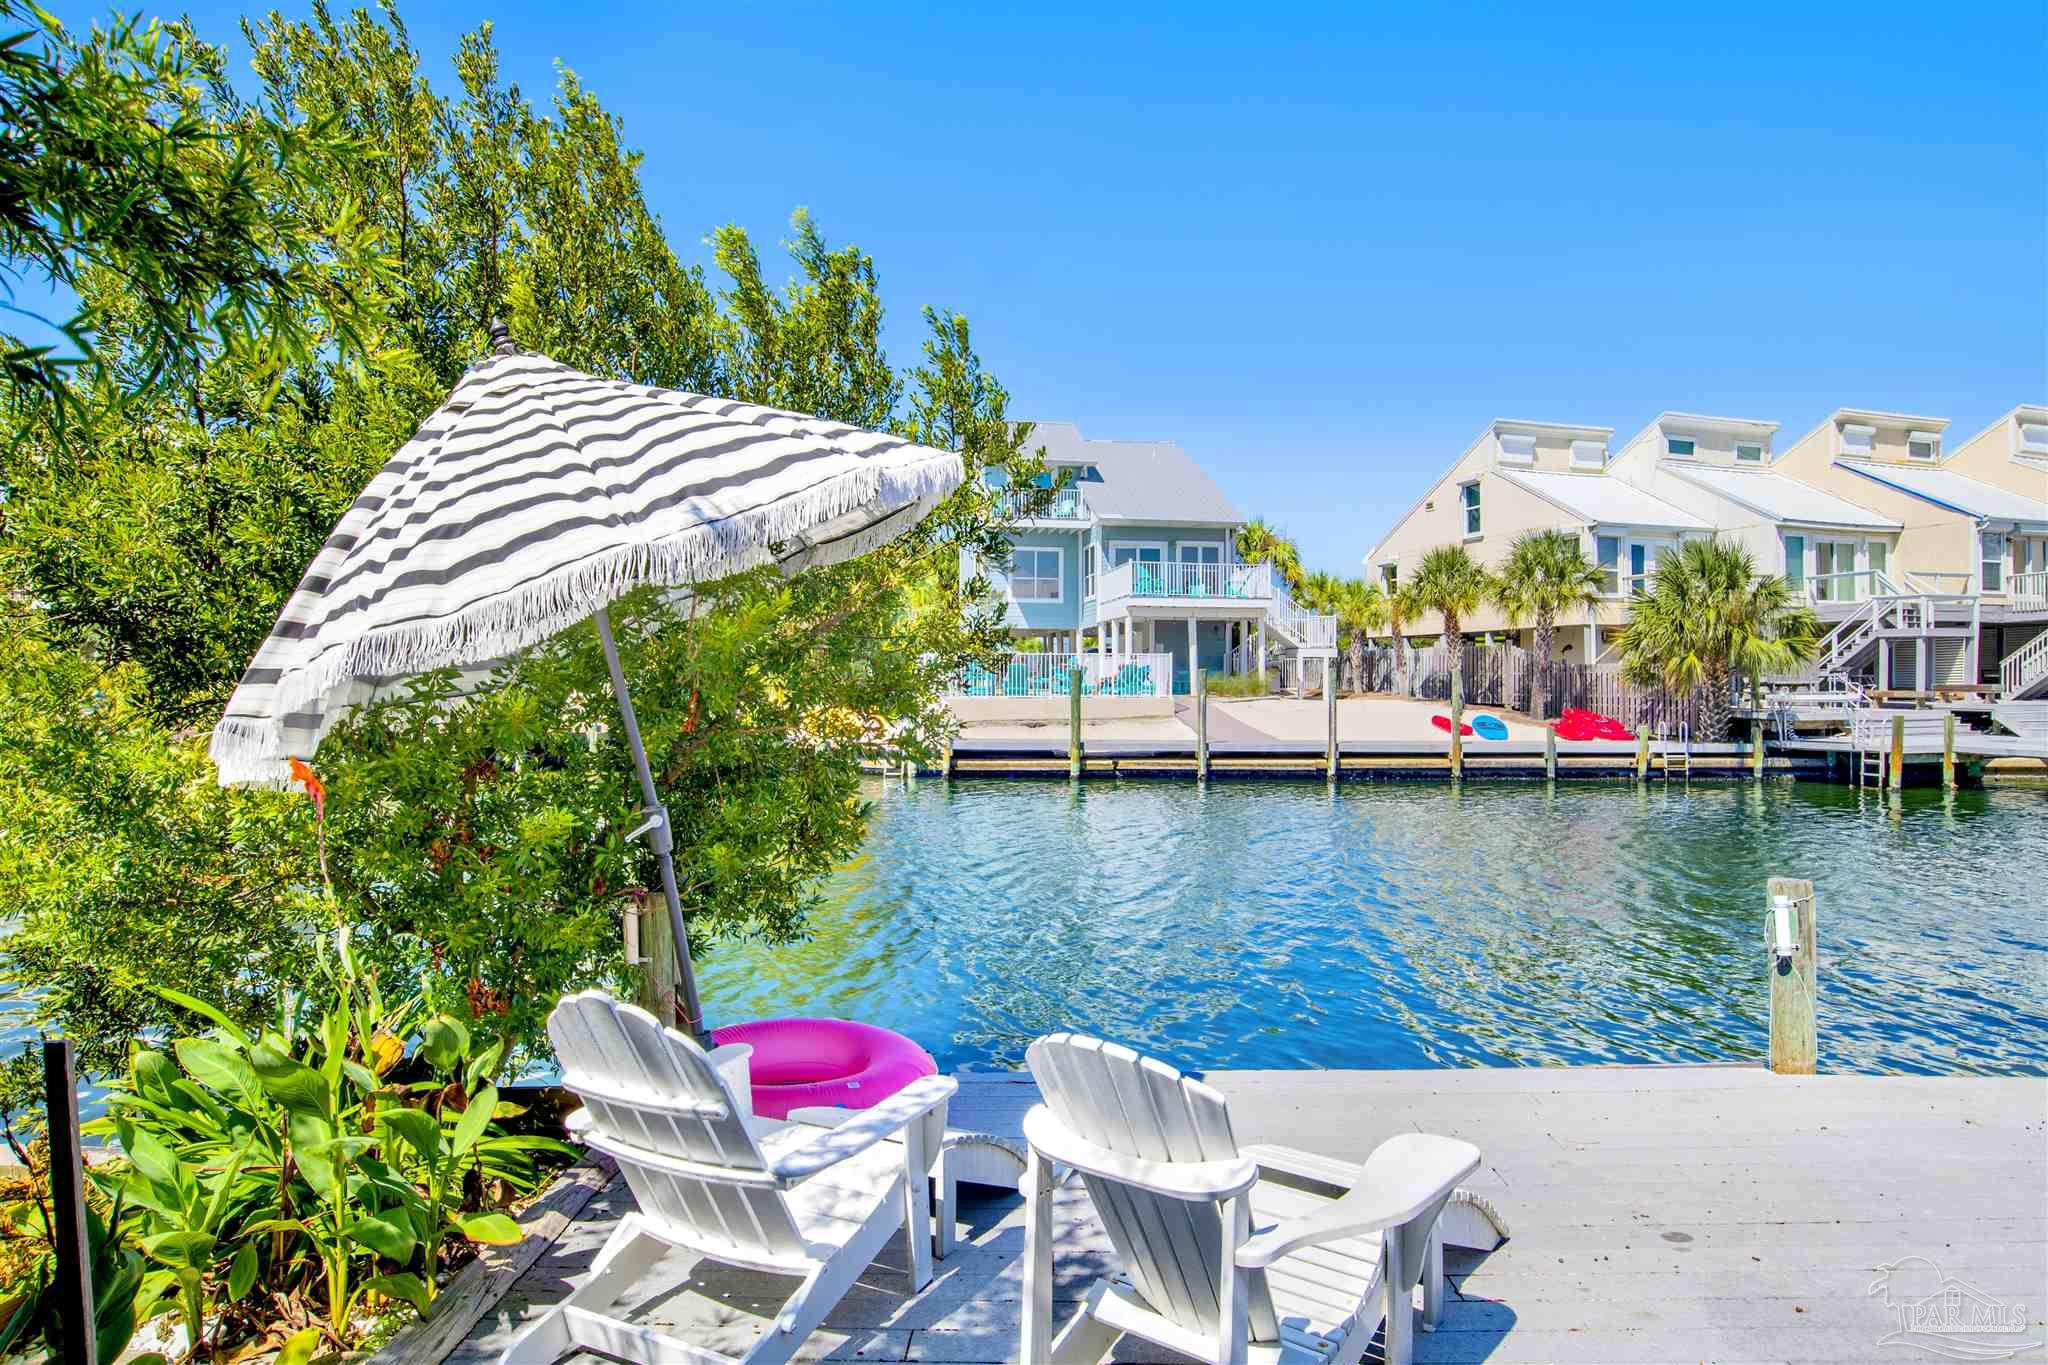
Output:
left=547, top=990, right=805, bottom=1259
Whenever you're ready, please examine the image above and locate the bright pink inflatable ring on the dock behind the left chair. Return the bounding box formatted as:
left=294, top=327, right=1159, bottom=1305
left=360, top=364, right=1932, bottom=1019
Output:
left=711, top=1019, right=938, bottom=1119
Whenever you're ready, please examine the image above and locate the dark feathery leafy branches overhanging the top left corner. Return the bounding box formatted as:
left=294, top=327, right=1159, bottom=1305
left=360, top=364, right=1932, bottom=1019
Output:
left=0, top=0, right=387, bottom=424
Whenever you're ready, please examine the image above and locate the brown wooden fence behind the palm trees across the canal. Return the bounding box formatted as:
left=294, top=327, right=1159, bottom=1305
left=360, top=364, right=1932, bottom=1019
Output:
left=1337, top=643, right=1700, bottom=737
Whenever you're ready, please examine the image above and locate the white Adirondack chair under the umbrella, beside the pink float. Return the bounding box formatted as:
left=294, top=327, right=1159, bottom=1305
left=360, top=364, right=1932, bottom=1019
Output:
left=498, top=990, right=958, bottom=1365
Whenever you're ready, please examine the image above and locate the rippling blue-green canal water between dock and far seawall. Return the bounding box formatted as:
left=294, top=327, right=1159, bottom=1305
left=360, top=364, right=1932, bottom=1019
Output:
left=702, top=782, right=2048, bottom=1072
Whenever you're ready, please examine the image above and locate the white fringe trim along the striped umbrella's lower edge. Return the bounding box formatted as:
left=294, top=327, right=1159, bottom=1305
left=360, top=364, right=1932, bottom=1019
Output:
left=207, top=454, right=961, bottom=788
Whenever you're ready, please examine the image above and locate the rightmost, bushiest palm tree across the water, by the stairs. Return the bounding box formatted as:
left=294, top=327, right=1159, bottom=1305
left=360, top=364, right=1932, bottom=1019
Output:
left=1620, top=536, right=1821, bottom=741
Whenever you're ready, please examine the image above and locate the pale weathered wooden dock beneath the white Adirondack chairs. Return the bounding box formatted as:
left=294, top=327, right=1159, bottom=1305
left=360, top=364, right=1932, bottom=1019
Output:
left=428, top=1066, right=2048, bottom=1365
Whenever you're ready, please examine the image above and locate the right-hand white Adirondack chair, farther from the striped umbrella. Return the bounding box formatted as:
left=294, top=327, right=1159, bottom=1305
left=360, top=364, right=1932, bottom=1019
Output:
left=1022, top=1033, right=1479, bottom=1365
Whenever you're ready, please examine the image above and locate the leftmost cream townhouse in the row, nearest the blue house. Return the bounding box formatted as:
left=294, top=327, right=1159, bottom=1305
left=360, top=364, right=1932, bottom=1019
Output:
left=1366, top=417, right=1712, bottom=663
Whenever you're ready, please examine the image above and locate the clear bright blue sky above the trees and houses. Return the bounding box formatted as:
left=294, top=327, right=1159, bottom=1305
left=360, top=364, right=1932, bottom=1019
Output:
left=48, top=0, right=2048, bottom=573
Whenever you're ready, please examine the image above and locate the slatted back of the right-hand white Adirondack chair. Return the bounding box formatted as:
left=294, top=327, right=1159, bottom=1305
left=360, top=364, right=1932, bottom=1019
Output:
left=1028, top=1033, right=1278, bottom=1340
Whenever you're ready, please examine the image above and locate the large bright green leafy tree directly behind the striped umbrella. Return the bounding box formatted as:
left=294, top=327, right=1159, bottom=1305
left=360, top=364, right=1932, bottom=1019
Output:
left=0, top=4, right=1024, bottom=1068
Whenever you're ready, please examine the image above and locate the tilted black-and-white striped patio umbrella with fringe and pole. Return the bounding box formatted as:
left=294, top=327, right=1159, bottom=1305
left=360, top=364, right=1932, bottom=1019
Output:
left=209, top=323, right=963, bottom=1033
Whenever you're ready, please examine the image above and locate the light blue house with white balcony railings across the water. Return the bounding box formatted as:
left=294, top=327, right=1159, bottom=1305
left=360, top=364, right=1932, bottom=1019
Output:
left=961, top=422, right=1335, bottom=694
